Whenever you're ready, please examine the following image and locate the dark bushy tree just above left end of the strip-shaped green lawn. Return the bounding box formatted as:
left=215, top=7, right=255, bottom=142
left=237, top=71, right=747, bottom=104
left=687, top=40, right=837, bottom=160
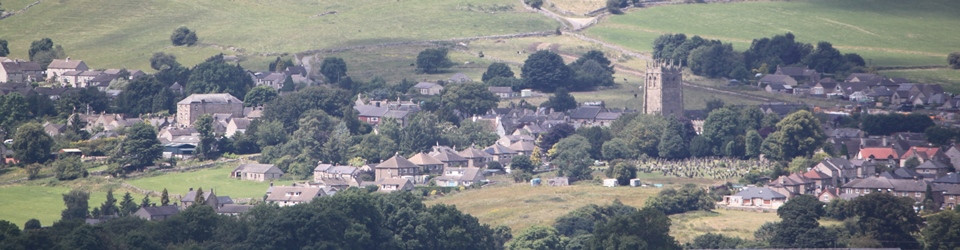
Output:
left=114, top=122, right=163, bottom=171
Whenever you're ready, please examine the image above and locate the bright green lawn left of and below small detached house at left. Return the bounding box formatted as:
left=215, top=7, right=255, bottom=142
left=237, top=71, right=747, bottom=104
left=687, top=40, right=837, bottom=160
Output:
left=126, top=163, right=276, bottom=201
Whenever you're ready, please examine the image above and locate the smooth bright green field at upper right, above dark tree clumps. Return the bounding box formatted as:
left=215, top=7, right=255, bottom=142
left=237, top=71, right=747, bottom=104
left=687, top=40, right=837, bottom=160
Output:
left=587, top=0, right=960, bottom=66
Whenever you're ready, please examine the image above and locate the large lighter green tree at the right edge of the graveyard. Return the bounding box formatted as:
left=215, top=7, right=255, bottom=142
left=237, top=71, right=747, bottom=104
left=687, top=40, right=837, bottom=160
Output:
left=761, top=110, right=826, bottom=161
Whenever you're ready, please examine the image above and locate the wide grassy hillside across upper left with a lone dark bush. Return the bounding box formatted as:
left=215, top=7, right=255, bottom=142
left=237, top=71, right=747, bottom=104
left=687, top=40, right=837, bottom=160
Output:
left=0, top=0, right=556, bottom=69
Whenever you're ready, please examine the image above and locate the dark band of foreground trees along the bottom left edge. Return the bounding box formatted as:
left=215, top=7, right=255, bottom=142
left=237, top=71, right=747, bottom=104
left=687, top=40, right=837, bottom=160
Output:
left=0, top=189, right=512, bottom=249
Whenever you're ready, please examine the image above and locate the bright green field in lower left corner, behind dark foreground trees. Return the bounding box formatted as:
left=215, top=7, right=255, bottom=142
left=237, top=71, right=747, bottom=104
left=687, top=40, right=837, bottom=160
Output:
left=0, top=186, right=108, bottom=227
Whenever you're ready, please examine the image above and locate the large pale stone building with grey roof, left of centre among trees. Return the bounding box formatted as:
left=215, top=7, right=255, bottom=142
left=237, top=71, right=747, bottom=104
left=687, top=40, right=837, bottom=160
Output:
left=177, top=93, right=243, bottom=126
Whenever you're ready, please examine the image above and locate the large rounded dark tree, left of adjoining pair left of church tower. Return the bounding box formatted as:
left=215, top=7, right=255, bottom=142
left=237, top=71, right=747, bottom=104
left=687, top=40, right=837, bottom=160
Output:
left=520, top=50, right=573, bottom=92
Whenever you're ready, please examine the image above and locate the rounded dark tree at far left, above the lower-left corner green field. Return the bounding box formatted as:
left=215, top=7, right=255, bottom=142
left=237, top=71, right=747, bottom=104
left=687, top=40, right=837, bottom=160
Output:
left=10, top=122, right=53, bottom=164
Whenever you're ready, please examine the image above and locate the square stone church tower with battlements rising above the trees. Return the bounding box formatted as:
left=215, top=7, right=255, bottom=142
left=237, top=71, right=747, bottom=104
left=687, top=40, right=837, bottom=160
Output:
left=643, top=61, right=683, bottom=118
